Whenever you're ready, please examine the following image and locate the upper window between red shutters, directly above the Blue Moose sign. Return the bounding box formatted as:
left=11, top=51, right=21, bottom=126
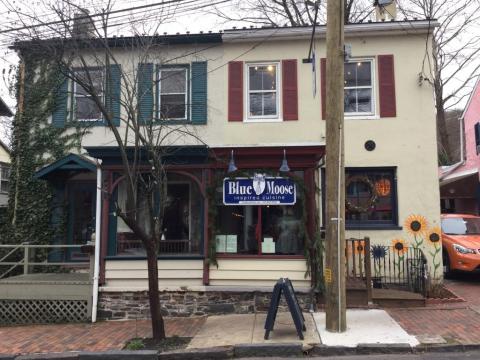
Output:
left=247, top=63, right=279, bottom=120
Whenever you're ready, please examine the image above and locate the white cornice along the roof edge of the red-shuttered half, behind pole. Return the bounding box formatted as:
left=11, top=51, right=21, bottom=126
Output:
left=222, top=20, right=439, bottom=42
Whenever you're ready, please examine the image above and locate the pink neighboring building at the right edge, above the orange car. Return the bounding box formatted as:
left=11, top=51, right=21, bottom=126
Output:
left=440, top=77, right=480, bottom=215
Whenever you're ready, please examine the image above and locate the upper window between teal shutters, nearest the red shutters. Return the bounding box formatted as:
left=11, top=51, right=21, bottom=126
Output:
left=158, top=68, right=189, bottom=120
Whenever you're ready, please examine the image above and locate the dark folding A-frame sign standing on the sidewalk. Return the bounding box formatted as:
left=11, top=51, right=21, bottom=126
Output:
left=264, top=278, right=307, bottom=340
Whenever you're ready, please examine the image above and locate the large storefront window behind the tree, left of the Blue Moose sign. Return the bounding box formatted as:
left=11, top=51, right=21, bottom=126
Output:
left=117, top=174, right=203, bottom=256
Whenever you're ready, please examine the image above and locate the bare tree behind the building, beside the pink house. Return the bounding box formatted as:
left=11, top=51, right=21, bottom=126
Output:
left=399, top=0, right=480, bottom=165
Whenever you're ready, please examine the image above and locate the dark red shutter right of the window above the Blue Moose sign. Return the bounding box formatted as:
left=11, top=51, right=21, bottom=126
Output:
left=282, top=60, right=298, bottom=120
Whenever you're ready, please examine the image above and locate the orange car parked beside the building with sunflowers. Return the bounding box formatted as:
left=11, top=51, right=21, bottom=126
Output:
left=442, top=214, right=480, bottom=275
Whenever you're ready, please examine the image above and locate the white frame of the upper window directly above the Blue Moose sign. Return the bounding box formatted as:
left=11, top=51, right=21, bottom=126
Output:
left=244, top=61, right=282, bottom=122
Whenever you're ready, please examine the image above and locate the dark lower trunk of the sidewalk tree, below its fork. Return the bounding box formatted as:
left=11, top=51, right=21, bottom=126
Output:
left=146, top=239, right=165, bottom=341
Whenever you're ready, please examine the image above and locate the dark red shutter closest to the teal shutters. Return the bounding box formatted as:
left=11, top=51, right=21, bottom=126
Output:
left=228, top=61, right=243, bottom=121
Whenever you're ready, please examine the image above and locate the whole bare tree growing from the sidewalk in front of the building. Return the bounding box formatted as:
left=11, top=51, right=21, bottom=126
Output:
left=5, top=1, right=206, bottom=340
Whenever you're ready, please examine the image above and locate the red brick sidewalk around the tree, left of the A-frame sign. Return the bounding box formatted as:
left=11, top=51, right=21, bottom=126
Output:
left=0, top=317, right=206, bottom=354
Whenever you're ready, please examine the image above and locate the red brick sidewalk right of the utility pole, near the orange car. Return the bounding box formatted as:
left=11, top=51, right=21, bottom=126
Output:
left=386, top=278, right=480, bottom=344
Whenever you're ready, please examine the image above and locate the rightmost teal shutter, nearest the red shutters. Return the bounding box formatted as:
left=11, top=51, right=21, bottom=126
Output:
left=192, top=61, right=207, bottom=124
